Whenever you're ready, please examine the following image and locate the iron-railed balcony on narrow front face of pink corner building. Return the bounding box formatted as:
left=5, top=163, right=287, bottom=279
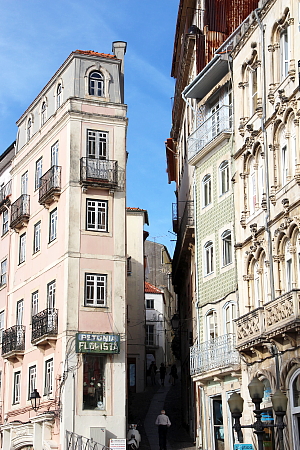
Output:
left=80, top=158, right=125, bottom=190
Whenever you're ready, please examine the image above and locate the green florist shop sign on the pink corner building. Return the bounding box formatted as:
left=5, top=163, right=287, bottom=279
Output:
left=76, top=333, right=120, bottom=353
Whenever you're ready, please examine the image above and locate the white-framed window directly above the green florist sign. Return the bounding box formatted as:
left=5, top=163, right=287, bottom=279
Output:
left=85, top=273, right=107, bottom=306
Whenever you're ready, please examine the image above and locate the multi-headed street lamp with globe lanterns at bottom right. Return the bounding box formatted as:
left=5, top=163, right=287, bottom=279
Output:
left=228, top=377, right=287, bottom=450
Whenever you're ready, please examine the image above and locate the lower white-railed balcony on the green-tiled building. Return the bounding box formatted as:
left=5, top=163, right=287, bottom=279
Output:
left=190, top=334, right=240, bottom=377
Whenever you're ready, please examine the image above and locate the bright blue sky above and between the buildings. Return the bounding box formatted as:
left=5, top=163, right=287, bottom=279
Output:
left=0, top=0, right=179, bottom=254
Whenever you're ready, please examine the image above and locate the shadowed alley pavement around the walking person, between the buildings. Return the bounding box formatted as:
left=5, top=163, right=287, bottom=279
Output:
left=129, top=375, right=196, bottom=450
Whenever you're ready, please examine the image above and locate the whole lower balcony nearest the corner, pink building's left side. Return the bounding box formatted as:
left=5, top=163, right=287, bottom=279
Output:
left=31, top=308, right=58, bottom=347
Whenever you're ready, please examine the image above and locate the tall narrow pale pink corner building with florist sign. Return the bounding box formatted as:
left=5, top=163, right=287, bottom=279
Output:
left=0, top=42, right=127, bottom=449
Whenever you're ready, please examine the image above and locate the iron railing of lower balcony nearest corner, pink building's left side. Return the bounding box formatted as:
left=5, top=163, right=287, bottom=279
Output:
left=31, top=308, right=58, bottom=342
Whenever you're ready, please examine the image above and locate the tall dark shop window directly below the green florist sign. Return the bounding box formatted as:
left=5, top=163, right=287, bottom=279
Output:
left=82, top=354, right=106, bottom=410
